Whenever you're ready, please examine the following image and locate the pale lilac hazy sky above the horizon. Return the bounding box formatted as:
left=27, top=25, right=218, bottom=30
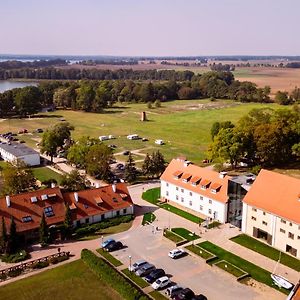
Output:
left=0, top=0, right=300, bottom=56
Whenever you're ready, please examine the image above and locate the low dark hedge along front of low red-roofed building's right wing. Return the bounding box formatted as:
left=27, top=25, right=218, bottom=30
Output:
left=75, top=215, right=134, bottom=236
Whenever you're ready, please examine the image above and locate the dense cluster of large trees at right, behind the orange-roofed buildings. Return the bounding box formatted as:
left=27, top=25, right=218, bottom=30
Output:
left=209, top=106, right=300, bottom=167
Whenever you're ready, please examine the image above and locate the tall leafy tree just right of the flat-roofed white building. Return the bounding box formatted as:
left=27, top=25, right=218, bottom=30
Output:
left=40, top=122, right=74, bottom=162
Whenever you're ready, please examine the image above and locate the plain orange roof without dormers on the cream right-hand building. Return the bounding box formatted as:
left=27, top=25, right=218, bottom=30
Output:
left=243, top=170, right=300, bottom=224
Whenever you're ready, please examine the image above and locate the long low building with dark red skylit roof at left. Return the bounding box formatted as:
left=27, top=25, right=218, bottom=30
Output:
left=0, top=183, right=134, bottom=240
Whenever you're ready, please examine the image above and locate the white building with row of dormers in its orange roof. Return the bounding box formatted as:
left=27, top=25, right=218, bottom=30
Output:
left=160, top=158, right=242, bottom=223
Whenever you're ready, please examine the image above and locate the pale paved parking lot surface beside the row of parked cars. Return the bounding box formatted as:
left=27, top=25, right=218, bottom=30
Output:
left=112, top=225, right=285, bottom=300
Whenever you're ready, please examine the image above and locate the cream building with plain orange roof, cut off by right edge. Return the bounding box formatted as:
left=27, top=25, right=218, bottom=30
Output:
left=242, top=170, right=300, bottom=258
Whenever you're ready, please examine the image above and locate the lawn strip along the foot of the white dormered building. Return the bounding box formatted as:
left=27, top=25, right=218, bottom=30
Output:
left=142, top=188, right=204, bottom=224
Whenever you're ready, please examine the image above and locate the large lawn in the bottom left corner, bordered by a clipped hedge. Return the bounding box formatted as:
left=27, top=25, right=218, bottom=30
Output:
left=0, top=260, right=122, bottom=300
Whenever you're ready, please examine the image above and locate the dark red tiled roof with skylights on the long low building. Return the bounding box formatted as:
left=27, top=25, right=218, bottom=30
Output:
left=0, top=183, right=132, bottom=232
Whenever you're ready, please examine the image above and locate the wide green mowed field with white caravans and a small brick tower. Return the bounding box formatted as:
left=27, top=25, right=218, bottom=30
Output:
left=0, top=100, right=279, bottom=163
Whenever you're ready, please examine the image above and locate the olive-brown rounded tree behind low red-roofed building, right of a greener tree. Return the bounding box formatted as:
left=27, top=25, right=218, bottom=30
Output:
left=86, top=144, right=113, bottom=180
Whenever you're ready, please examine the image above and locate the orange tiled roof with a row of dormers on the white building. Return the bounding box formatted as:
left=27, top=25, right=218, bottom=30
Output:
left=160, top=159, right=231, bottom=203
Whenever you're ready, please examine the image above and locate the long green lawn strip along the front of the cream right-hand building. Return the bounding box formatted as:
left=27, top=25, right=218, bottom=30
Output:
left=231, top=234, right=300, bottom=272
